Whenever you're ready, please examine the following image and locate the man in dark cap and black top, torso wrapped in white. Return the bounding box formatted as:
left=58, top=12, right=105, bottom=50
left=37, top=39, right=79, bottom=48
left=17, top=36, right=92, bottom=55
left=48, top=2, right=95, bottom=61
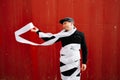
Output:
left=31, top=17, right=87, bottom=80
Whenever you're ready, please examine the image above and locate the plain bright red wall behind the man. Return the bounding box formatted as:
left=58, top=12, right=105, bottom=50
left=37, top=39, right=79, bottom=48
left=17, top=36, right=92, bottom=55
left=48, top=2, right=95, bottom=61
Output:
left=0, top=0, right=120, bottom=80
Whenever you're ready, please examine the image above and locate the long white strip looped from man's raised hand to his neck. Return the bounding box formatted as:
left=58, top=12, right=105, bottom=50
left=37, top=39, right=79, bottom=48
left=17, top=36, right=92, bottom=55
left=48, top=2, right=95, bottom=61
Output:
left=15, top=22, right=76, bottom=46
